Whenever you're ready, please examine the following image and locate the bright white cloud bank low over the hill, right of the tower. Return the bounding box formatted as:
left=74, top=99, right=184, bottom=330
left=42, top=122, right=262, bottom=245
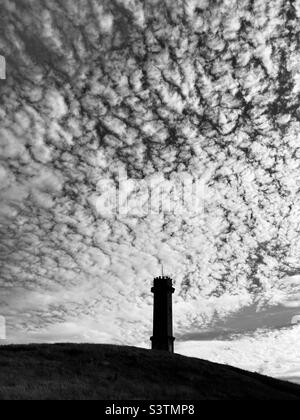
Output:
left=177, top=326, right=300, bottom=383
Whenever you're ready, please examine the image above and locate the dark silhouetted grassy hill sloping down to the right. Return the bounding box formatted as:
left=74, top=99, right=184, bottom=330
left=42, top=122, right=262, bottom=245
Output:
left=0, top=344, right=300, bottom=400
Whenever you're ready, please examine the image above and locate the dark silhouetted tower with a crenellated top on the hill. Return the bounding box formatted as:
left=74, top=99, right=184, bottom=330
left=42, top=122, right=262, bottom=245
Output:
left=151, top=276, right=175, bottom=353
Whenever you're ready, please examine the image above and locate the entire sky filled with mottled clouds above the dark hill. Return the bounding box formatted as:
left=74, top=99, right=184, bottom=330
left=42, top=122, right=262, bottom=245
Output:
left=0, top=0, right=300, bottom=380
